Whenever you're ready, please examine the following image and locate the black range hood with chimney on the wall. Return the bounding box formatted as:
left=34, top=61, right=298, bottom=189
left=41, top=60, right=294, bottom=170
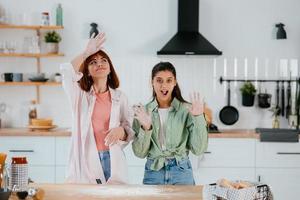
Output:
left=157, top=0, right=222, bottom=55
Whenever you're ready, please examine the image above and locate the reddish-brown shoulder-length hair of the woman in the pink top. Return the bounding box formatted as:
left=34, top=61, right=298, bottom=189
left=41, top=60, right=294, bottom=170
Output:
left=78, top=50, right=120, bottom=92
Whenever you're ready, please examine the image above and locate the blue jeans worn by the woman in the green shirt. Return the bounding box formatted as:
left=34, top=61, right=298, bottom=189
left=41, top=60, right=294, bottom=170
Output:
left=143, top=158, right=195, bottom=185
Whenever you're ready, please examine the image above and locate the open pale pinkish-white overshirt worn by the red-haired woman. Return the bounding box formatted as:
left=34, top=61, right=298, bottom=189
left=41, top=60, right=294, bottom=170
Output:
left=61, top=63, right=134, bottom=184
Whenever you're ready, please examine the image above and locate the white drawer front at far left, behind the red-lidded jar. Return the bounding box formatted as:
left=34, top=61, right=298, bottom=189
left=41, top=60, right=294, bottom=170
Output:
left=0, top=136, right=55, bottom=166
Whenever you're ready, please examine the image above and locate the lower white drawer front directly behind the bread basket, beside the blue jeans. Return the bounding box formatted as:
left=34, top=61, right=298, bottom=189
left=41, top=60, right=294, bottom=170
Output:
left=194, top=167, right=255, bottom=185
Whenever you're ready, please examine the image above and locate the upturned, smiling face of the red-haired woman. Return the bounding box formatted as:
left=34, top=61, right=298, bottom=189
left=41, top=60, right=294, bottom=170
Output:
left=88, top=55, right=110, bottom=78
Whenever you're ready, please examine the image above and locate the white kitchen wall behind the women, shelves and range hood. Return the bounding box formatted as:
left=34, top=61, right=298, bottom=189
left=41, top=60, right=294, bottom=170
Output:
left=0, top=0, right=300, bottom=128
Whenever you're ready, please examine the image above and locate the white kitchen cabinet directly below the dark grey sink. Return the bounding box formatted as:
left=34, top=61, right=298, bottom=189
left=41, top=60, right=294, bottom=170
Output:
left=256, top=141, right=300, bottom=200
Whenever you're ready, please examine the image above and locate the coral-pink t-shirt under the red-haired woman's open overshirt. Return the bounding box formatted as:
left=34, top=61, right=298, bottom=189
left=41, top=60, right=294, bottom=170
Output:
left=92, top=90, right=111, bottom=151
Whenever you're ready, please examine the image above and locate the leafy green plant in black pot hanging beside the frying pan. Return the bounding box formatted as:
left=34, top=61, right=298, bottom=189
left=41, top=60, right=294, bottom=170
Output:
left=240, top=81, right=256, bottom=106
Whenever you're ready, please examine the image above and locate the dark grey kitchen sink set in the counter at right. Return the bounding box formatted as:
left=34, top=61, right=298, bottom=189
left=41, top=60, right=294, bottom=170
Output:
left=255, top=128, right=300, bottom=142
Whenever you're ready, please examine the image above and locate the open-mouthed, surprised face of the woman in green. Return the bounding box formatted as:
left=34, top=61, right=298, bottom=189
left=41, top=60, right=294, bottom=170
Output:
left=152, top=70, right=176, bottom=103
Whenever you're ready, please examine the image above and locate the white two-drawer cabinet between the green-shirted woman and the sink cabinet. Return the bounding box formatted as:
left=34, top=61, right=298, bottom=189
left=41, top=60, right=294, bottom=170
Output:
left=190, top=138, right=255, bottom=184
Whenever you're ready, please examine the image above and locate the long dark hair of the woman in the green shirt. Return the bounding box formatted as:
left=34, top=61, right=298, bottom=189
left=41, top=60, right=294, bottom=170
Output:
left=151, top=62, right=188, bottom=103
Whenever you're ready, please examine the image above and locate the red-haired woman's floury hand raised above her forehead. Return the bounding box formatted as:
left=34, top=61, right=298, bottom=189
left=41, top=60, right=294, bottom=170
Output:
left=84, top=32, right=105, bottom=59
